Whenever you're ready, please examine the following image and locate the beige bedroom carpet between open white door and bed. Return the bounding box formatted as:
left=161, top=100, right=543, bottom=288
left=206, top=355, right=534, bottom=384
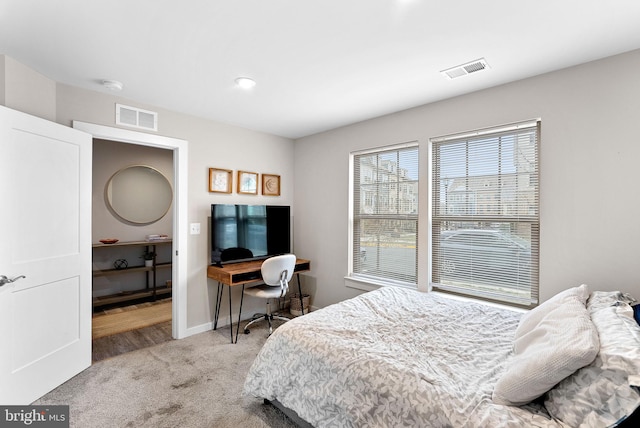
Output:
left=33, top=323, right=295, bottom=428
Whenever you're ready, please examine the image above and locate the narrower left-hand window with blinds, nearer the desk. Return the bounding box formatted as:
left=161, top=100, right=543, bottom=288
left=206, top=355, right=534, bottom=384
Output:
left=351, top=143, right=418, bottom=286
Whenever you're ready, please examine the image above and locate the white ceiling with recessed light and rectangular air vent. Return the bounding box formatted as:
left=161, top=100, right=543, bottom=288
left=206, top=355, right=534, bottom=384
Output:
left=0, top=0, right=640, bottom=138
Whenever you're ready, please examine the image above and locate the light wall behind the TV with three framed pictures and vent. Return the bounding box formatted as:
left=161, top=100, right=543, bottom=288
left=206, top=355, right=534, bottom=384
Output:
left=56, top=84, right=294, bottom=329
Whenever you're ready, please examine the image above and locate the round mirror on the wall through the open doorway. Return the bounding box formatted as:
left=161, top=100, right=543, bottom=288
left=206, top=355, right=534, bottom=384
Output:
left=105, top=165, right=173, bottom=224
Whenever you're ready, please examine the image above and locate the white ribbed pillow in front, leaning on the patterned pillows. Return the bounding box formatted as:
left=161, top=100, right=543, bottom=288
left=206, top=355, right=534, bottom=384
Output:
left=493, top=296, right=600, bottom=406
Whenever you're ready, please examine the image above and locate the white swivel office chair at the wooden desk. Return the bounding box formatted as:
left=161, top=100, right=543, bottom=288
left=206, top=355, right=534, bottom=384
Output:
left=244, top=254, right=296, bottom=335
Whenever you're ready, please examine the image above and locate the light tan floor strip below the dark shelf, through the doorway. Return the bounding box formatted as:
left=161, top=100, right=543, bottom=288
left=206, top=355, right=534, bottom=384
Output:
left=92, top=300, right=171, bottom=339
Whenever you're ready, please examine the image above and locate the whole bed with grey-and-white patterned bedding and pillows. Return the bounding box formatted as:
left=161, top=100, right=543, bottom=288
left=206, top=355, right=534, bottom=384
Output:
left=244, top=285, right=640, bottom=428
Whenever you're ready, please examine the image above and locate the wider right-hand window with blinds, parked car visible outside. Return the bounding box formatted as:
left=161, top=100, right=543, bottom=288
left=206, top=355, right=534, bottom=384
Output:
left=431, top=121, right=540, bottom=306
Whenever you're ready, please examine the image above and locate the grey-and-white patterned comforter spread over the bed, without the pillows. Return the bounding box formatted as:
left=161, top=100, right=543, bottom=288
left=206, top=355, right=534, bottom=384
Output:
left=244, top=287, right=565, bottom=428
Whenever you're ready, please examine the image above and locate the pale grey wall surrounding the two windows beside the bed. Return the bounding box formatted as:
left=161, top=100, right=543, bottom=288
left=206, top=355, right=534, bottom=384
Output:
left=295, top=50, right=640, bottom=306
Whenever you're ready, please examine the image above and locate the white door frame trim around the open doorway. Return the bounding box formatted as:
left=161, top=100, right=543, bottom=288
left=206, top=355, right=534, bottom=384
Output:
left=72, top=120, right=189, bottom=339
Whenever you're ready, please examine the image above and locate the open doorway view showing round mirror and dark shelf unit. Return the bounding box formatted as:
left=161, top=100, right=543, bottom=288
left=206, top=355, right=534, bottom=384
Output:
left=92, top=138, right=174, bottom=362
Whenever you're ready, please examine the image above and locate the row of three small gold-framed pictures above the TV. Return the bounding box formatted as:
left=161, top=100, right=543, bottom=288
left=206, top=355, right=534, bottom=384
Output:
left=209, top=168, right=280, bottom=196
